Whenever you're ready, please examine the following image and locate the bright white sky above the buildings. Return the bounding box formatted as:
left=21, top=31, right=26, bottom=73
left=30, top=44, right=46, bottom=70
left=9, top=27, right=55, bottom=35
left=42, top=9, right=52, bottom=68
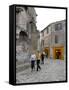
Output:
left=35, top=8, right=66, bottom=31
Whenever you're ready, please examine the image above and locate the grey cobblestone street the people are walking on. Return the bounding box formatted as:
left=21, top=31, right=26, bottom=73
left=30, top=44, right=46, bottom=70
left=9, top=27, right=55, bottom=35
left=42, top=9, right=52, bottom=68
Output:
left=16, top=59, right=66, bottom=83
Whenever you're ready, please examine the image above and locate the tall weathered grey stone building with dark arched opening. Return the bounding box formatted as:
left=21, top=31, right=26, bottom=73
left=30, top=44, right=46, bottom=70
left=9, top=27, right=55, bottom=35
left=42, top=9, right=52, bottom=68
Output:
left=16, top=7, right=39, bottom=61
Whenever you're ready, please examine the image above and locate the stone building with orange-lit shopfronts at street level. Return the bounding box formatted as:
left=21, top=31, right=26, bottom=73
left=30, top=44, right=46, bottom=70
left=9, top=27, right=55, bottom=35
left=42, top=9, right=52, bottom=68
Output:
left=40, top=20, right=66, bottom=59
